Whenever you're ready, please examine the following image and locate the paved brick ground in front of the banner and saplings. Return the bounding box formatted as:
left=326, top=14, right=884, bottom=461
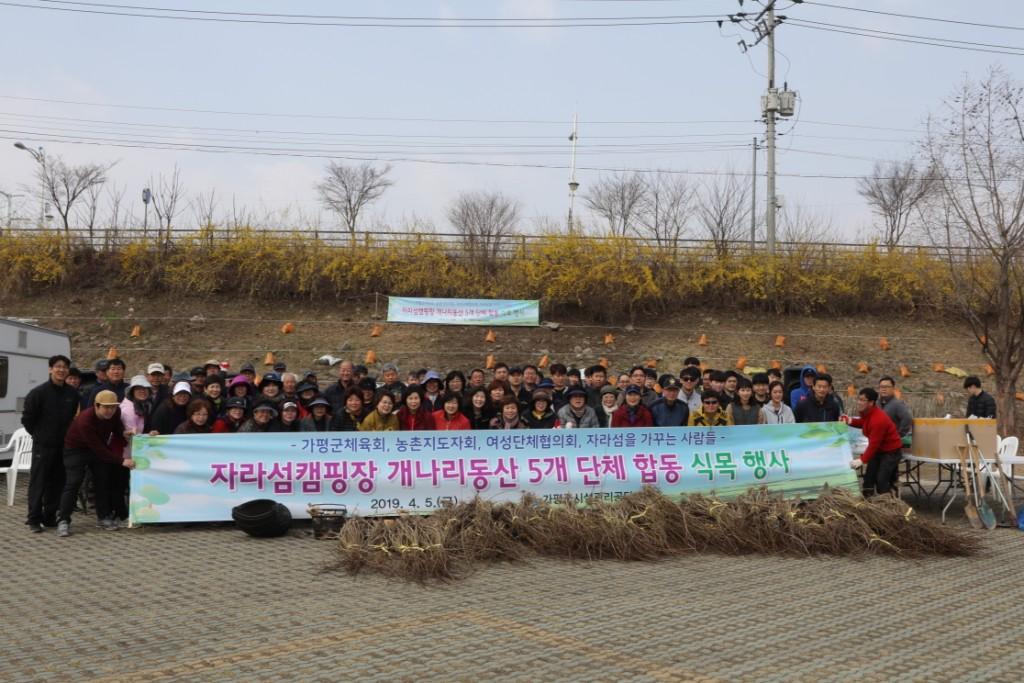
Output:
left=0, top=487, right=1024, bottom=683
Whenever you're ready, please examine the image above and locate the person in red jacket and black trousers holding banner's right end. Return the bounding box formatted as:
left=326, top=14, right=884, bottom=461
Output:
left=850, top=388, right=903, bottom=498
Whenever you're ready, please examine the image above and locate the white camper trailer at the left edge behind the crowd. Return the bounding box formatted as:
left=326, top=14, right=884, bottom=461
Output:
left=0, top=317, right=71, bottom=443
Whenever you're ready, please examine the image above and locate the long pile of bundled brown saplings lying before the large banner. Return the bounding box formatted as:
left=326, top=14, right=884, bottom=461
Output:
left=336, top=488, right=980, bottom=582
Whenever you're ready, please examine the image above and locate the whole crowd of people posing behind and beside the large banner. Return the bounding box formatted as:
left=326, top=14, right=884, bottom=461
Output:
left=16, top=355, right=995, bottom=536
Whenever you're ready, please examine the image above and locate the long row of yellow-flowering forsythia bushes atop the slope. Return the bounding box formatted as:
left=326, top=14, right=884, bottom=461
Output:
left=0, top=228, right=952, bottom=321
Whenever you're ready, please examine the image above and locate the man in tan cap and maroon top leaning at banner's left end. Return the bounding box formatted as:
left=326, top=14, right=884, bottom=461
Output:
left=57, top=390, right=135, bottom=537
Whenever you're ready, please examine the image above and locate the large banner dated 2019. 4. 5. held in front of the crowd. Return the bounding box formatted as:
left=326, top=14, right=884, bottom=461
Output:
left=131, top=422, right=859, bottom=524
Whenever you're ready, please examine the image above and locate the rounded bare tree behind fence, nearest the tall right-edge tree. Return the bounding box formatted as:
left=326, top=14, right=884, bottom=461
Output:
left=857, top=161, right=935, bottom=251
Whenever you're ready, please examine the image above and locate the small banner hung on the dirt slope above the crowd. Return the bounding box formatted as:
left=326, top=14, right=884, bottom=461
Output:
left=387, top=296, right=541, bottom=327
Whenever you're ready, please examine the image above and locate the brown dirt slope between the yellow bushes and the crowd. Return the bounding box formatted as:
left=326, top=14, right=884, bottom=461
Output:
left=0, top=291, right=985, bottom=416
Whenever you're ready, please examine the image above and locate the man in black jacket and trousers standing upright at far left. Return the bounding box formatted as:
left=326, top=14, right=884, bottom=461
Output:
left=22, top=355, right=79, bottom=533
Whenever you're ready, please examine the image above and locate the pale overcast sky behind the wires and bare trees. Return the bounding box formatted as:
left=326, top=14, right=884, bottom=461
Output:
left=0, top=0, right=1024, bottom=241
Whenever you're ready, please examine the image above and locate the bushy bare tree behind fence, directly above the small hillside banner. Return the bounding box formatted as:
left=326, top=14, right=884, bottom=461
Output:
left=447, top=191, right=519, bottom=268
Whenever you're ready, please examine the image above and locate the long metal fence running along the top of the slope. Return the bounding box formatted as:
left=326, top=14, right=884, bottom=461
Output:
left=3, top=227, right=972, bottom=261
